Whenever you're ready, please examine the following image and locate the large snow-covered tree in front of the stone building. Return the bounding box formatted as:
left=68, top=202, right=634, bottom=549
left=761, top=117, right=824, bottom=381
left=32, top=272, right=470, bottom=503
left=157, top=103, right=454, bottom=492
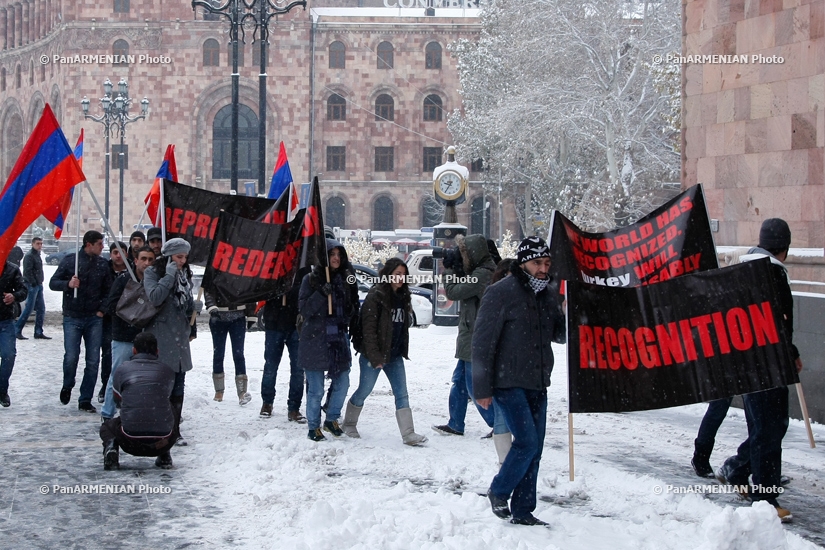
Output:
left=448, top=0, right=681, bottom=234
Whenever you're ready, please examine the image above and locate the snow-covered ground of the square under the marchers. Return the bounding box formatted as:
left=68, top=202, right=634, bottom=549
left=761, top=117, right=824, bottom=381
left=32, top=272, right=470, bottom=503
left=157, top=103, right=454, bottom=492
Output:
left=0, top=268, right=825, bottom=550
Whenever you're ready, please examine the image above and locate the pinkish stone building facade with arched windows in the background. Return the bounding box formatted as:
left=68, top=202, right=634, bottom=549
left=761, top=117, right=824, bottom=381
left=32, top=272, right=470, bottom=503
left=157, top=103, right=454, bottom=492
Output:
left=0, top=0, right=518, bottom=240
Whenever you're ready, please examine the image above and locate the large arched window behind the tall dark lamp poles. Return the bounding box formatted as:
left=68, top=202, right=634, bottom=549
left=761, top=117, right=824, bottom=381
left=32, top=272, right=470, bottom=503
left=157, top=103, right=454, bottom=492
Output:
left=212, top=104, right=258, bottom=179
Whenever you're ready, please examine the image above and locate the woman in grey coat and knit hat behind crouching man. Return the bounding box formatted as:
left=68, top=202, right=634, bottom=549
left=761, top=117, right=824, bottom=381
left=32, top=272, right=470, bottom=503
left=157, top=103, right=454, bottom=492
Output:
left=143, top=239, right=197, bottom=445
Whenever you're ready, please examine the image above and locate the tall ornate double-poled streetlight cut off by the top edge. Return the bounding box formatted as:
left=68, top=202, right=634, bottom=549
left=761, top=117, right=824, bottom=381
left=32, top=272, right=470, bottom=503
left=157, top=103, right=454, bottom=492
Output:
left=192, top=0, right=307, bottom=195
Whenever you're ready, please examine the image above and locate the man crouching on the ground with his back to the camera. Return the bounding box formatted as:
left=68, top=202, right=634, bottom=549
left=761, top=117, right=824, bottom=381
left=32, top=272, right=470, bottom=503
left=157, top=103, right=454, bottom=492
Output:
left=100, top=332, right=179, bottom=470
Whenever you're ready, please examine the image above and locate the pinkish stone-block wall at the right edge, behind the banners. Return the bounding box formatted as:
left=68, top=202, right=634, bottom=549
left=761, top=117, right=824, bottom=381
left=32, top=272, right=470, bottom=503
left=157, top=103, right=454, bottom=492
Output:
left=682, top=0, right=825, bottom=248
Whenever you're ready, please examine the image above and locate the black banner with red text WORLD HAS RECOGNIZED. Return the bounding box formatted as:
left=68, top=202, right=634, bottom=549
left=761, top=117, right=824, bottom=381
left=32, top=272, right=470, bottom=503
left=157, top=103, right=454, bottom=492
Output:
left=550, top=185, right=719, bottom=287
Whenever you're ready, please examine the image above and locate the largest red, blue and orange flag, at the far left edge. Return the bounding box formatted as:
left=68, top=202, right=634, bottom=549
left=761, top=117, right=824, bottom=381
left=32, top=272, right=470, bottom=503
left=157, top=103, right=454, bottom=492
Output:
left=0, top=104, right=86, bottom=265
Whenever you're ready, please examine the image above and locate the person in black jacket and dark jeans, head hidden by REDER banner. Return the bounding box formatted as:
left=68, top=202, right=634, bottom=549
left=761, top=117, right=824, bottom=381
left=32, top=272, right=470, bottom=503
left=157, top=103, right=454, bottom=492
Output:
left=260, top=269, right=309, bottom=424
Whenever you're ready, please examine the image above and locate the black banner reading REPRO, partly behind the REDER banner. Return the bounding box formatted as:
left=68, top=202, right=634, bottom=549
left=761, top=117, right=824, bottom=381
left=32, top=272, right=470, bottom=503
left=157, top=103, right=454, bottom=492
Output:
left=163, top=179, right=286, bottom=265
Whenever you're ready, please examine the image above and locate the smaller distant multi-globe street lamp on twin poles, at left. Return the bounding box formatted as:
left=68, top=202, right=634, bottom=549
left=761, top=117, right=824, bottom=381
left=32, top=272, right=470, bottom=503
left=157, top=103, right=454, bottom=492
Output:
left=80, top=78, right=149, bottom=238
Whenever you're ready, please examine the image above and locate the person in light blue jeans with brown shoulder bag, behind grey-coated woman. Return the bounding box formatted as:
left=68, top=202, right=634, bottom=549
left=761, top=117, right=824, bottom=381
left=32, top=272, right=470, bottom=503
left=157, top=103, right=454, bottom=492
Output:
left=100, top=246, right=155, bottom=420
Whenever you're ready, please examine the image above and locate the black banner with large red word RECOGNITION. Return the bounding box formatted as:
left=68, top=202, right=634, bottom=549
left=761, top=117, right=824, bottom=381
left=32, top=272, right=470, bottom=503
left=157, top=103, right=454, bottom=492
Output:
left=567, top=259, right=799, bottom=412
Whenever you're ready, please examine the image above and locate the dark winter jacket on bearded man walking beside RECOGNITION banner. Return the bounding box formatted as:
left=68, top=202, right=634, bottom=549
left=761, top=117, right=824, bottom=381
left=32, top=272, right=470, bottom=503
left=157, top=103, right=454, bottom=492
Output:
left=472, top=264, right=565, bottom=399
